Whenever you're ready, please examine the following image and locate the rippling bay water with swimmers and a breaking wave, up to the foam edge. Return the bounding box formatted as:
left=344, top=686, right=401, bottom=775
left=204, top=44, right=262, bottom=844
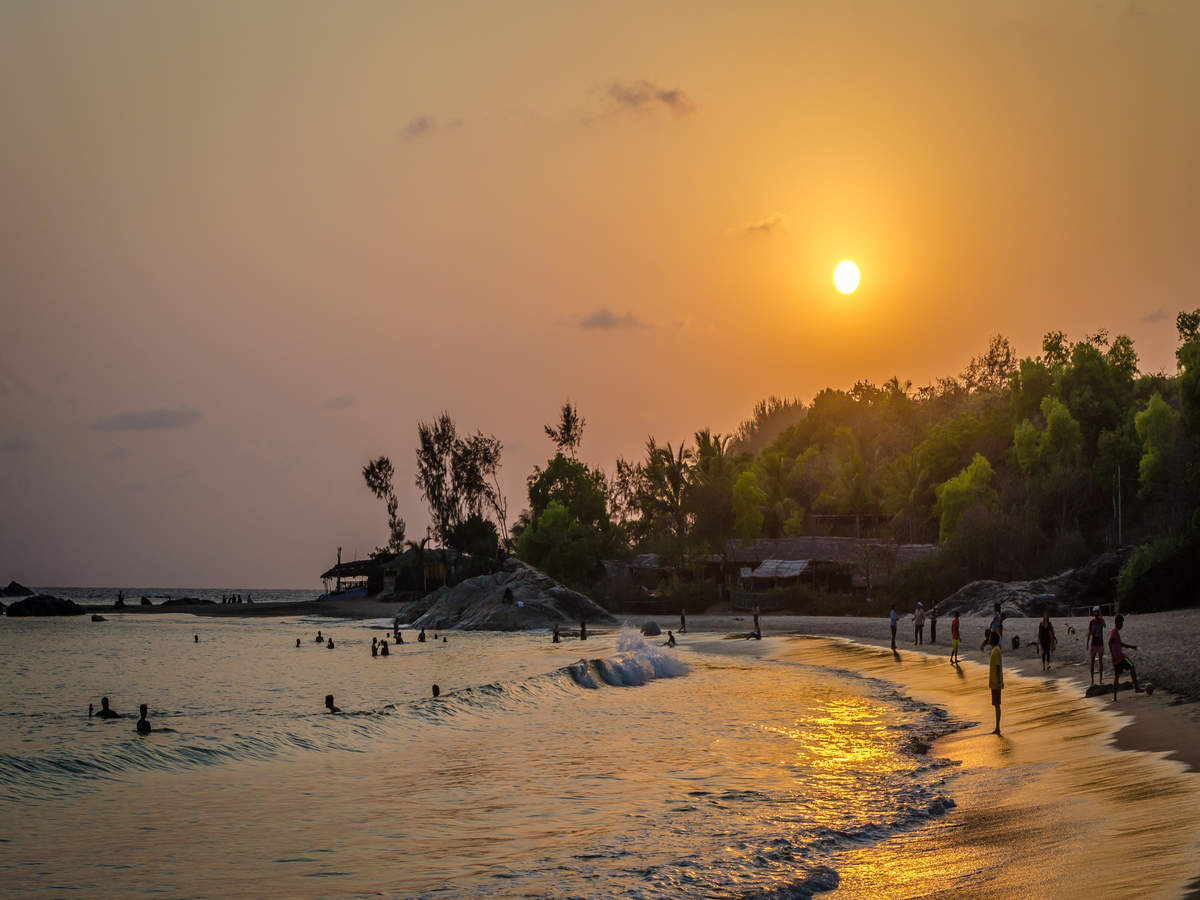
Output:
left=0, top=616, right=974, bottom=896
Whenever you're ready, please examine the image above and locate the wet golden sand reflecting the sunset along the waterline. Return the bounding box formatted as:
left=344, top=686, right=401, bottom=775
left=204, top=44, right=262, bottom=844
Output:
left=685, top=620, right=1200, bottom=898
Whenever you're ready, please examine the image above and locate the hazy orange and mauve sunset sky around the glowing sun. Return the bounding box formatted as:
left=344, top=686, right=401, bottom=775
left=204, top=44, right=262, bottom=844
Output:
left=0, top=0, right=1200, bottom=589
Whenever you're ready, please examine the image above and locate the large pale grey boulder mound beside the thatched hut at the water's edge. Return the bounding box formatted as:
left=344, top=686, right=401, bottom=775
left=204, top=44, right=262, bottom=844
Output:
left=412, top=557, right=617, bottom=631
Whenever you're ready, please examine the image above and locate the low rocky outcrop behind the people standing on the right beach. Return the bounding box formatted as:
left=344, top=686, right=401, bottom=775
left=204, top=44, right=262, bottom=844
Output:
left=936, top=552, right=1124, bottom=618
